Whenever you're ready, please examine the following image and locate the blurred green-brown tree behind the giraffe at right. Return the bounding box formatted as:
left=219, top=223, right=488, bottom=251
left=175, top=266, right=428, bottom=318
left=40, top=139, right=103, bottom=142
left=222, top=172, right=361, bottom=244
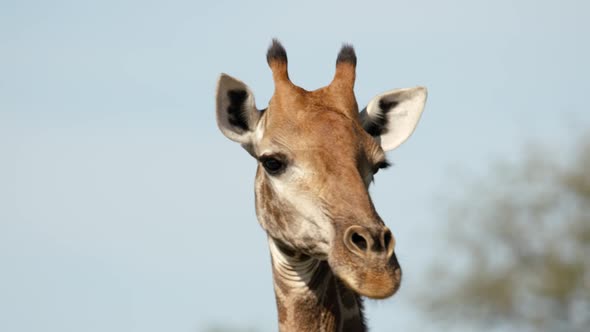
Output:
left=421, top=139, right=590, bottom=331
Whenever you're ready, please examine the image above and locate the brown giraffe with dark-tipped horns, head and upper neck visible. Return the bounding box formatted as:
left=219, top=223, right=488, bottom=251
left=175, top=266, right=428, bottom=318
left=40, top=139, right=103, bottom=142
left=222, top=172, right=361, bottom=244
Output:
left=216, top=39, right=427, bottom=332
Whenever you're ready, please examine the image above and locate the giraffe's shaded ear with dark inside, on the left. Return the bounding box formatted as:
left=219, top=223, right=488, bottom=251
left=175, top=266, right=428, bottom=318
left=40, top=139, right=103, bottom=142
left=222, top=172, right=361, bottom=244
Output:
left=216, top=74, right=260, bottom=146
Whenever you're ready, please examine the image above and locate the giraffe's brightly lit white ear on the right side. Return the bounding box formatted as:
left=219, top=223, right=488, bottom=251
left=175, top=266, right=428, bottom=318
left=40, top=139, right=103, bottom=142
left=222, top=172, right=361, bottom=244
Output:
left=360, top=87, right=427, bottom=151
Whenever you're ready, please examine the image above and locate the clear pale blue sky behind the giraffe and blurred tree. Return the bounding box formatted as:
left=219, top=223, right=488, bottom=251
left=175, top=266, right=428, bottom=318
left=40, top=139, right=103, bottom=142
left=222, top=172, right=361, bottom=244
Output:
left=0, top=0, right=590, bottom=332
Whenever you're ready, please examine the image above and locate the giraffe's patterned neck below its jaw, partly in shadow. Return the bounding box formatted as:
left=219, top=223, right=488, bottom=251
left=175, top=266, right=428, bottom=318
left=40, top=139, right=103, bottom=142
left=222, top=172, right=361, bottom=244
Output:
left=269, top=237, right=366, bottom=332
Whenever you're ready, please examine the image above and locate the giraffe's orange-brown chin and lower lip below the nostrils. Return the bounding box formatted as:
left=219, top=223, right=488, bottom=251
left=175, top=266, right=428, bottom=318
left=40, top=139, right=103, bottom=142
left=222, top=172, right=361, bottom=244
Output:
left=328, top=254, right=402, bottom=299
